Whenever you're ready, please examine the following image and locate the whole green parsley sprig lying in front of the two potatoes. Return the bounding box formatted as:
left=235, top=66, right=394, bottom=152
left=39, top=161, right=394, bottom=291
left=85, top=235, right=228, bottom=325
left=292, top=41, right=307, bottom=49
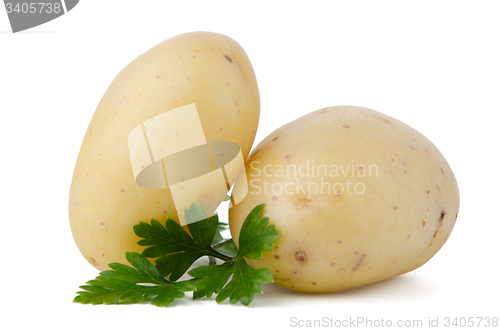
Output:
left=74, top=202, right=280, bottom=307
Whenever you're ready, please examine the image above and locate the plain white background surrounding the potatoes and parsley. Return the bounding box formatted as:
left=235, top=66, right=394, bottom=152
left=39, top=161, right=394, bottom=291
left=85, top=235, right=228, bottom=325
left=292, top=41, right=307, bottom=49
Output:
left=0, top=0, right=500, bottom=330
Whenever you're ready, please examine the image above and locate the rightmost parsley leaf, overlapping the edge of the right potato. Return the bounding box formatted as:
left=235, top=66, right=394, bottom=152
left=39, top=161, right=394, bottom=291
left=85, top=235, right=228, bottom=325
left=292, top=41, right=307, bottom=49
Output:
left=188, top=204, right=281, bottom=305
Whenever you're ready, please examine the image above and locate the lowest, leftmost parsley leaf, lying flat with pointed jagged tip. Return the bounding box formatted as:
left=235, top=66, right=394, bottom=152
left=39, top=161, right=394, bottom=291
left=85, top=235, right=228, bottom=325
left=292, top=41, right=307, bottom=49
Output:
left=73, top=252, right=195, bottom=307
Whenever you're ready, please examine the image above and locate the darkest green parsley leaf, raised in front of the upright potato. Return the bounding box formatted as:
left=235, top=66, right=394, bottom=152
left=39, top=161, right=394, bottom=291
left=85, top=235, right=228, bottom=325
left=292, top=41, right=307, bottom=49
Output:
left=133, top=202, right=231, bottom=281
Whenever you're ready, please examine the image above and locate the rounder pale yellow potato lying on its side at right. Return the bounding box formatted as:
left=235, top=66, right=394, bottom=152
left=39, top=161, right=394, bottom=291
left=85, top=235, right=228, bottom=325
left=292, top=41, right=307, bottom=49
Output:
left=229, top=106, right=459, bottom=292
